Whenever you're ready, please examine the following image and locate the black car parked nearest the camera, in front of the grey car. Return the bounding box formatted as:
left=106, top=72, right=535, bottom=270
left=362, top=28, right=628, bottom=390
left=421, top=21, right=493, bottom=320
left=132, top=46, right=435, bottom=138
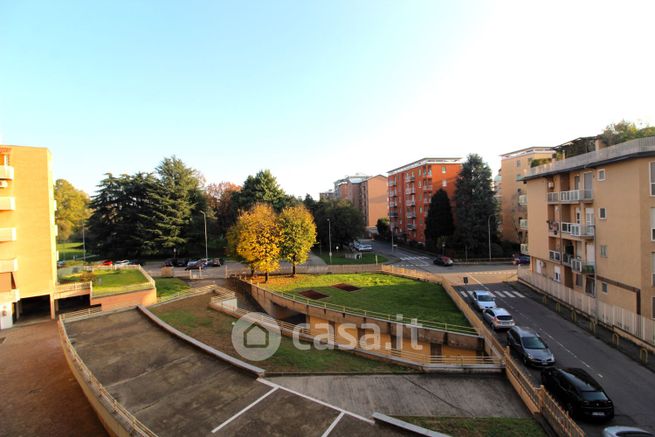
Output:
left=541, top=367, right=614, bottom=420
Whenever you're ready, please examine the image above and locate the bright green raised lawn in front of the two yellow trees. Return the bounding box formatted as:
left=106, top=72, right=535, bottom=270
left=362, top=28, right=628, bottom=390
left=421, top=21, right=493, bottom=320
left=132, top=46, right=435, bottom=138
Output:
left=260, top=273, right=470, bottom=326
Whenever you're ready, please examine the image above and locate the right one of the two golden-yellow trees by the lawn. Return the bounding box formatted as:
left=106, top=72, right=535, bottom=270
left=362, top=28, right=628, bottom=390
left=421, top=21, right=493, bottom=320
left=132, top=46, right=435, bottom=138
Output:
left=278, top=205, right=316, bottom=276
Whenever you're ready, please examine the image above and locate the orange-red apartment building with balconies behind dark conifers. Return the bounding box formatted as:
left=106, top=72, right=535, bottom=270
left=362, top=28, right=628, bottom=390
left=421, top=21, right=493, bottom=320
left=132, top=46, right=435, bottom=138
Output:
left=387, top=158, right=462, bottom=244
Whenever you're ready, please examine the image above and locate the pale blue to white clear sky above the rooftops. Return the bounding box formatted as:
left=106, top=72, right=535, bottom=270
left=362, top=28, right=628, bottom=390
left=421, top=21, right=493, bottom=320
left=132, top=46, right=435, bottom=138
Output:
left=0, top=0, right=655, bottom=197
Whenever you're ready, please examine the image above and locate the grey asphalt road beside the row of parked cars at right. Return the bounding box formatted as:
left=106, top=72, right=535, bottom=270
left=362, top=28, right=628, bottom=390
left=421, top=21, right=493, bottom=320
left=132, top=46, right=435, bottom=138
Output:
left=457, top=273, right=655, bottom=436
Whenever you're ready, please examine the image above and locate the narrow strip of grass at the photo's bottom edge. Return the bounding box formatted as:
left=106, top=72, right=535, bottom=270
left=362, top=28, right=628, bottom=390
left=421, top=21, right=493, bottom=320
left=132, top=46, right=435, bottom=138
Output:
left=398, top=417, right=546, bottom=437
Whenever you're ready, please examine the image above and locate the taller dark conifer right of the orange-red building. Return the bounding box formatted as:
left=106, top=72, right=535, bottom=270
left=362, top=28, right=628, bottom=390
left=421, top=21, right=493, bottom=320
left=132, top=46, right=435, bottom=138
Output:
left=455, top=154, right=497, bottom=256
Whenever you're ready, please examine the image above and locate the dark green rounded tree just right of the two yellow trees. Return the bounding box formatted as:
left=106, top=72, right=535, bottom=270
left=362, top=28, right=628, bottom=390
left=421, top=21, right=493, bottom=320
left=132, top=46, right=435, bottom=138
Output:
left=314, top=199, right=364, bottom=247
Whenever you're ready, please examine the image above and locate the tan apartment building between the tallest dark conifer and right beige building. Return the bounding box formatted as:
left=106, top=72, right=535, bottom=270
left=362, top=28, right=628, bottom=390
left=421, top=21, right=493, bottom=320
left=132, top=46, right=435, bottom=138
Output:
left=496, top=147, right=555, bottom=243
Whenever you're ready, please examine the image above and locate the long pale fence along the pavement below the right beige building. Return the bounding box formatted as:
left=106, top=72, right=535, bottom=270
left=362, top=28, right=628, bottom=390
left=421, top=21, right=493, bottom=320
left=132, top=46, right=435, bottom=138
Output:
left=518, top=269, right=655, bottom=347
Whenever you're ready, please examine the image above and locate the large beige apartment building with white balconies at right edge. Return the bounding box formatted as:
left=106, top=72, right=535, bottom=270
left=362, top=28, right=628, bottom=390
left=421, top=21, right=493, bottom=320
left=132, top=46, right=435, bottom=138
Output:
left=524, top=137, right=655, bottom=318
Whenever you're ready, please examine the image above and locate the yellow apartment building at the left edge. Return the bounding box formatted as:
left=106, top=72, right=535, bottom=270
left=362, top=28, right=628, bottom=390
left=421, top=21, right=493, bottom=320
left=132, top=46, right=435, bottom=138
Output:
left=0, top=146, right=57, bottom=329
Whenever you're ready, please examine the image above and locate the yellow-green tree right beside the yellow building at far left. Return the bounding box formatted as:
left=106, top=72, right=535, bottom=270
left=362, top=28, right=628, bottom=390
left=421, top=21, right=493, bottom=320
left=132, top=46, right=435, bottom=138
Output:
left=55, top=179, right=91, bottom=241
